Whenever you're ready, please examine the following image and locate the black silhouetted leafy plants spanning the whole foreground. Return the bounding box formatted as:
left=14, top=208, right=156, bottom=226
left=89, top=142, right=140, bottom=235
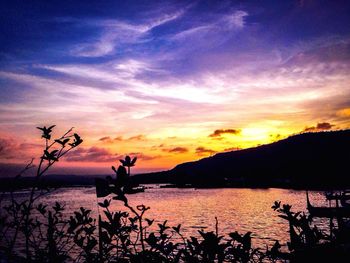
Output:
left=0, top=126, right=349, bottom=263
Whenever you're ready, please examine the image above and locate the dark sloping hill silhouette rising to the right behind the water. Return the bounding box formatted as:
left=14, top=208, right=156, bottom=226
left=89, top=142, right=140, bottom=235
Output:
left=134, top=130, right=350, bottom=188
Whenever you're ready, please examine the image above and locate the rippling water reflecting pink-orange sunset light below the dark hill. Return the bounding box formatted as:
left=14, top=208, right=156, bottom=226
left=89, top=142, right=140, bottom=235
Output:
left=35, top=188, right=328, bottom=251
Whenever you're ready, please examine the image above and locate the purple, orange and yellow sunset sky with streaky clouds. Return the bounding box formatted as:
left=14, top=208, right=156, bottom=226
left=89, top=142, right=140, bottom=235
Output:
left=0, top=0, right=350, bottom=174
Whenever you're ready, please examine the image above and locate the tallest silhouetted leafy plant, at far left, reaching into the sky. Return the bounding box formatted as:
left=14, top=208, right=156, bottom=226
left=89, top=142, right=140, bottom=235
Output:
left=0, top=125, right=83, bottom=261
